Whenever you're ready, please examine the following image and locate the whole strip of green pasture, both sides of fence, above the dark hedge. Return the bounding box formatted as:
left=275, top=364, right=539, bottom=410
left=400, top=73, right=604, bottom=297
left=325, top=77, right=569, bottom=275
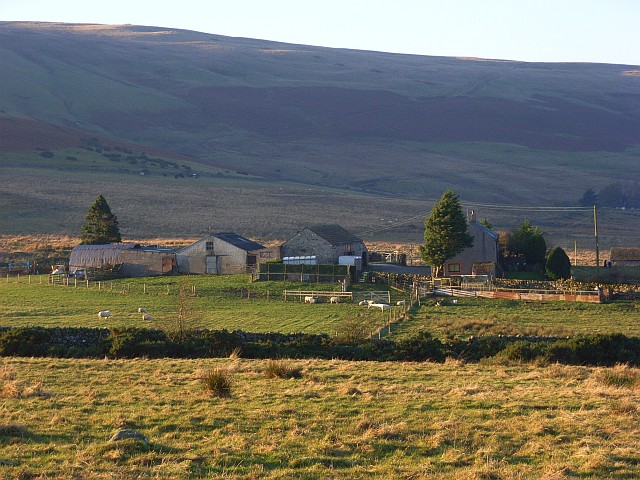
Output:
left=0, top=275, right=640, bottom=340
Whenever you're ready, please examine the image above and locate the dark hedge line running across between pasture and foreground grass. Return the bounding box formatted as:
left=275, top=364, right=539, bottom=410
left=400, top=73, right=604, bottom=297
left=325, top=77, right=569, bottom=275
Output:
left=0, top=327, right=640, bottom=366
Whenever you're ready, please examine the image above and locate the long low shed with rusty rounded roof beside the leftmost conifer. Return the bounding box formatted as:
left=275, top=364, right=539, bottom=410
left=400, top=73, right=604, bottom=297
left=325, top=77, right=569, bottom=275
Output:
left=69, top=243, right=176, bottom=277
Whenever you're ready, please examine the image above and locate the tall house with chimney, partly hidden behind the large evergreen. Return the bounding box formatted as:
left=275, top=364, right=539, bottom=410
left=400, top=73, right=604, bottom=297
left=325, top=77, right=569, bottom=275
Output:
left=444, top=218, right=500, bottom=276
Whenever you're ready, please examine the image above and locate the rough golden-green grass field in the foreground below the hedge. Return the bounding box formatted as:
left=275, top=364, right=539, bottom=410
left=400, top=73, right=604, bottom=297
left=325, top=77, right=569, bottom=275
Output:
left=0, top=358, right=640, bottom=480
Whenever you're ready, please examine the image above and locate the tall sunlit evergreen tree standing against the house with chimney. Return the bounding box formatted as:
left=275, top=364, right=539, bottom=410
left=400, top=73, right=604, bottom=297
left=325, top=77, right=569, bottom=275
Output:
left=420, top=190, right=473, bottom=277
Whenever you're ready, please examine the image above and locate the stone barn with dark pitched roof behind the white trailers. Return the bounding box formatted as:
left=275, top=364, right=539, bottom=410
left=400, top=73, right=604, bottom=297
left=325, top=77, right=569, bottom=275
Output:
left=281, top=225, right=367, bottom=266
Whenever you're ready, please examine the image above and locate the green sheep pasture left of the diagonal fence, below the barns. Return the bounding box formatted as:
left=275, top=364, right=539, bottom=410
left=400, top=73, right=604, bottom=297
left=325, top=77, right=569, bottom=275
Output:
left=0, top=275, right=400, bottom=333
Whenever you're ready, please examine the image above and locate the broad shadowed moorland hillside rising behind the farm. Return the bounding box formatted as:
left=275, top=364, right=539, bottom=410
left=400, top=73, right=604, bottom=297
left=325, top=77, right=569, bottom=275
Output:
left=0, top=22, right=640, bottom=241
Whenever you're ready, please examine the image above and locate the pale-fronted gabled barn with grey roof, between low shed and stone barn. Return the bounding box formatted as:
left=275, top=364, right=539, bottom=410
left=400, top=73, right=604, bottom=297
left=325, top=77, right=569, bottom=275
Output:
left=176, top=233, right=280, bottom=274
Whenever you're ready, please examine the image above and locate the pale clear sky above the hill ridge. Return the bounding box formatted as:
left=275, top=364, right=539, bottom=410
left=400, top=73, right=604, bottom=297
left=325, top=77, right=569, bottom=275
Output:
left=0, top=0, right=640, bottom=65
